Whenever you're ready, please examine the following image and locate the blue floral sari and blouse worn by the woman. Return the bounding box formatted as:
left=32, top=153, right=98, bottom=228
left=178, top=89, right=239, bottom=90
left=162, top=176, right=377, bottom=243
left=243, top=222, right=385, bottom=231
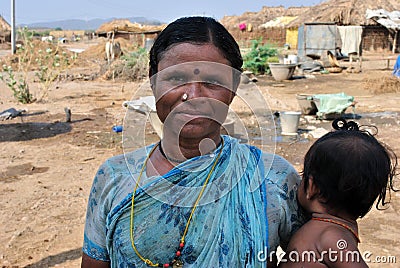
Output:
left=83, top=136, right=300, bottom=267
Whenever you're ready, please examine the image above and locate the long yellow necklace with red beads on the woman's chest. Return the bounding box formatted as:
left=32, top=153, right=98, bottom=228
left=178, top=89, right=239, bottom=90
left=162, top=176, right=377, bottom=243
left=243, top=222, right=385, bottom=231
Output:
left=130, top=138, right=224, bottom=267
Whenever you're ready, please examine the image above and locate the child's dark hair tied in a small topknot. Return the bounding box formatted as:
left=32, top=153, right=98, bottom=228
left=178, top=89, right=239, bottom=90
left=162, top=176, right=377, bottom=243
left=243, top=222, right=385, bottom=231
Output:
left=303, top=119, right=397, bottom=217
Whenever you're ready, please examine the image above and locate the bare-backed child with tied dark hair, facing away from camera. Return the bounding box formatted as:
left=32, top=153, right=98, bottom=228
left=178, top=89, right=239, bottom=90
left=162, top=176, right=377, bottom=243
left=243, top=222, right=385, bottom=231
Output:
left=279, top=119, right=397, bottom=268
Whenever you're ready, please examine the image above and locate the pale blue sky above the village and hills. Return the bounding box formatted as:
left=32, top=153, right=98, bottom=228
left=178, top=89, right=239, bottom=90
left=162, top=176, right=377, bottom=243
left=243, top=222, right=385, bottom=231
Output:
left=0, top=0, right=323, bottom=24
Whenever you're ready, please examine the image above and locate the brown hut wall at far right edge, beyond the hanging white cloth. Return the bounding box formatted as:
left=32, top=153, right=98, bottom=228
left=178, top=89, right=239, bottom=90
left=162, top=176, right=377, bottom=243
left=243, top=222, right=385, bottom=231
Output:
left=362, top=25, right=400, bottom=52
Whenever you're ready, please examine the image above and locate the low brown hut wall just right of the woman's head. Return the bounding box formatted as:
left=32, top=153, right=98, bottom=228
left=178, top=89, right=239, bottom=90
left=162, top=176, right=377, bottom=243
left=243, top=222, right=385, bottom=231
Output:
left=230, top=27, right=286, bottom=47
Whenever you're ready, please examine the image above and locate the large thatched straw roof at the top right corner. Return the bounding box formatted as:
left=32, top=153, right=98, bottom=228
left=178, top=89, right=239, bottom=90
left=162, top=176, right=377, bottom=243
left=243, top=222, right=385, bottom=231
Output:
left=287, top=0, right=400, bottom=28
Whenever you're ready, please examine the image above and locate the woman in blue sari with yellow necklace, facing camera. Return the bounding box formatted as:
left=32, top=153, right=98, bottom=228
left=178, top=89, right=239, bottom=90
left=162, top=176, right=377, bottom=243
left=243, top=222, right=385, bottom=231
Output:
left=82, top=17, right=301, bottom=267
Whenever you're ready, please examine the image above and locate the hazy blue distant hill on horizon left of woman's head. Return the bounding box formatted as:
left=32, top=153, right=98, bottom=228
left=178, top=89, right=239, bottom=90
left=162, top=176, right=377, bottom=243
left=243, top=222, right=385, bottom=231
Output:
left=18, top=17, right=163, bottom=30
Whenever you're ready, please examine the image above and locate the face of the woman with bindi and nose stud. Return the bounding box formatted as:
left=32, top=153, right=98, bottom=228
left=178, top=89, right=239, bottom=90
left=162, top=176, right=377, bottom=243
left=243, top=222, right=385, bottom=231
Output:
left=153, top=43, right=236, bottom=138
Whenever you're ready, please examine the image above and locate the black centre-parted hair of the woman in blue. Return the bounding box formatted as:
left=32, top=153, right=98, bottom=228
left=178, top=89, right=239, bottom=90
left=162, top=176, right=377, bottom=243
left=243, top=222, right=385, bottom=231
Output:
left=149, top=17, right=243, bottom=78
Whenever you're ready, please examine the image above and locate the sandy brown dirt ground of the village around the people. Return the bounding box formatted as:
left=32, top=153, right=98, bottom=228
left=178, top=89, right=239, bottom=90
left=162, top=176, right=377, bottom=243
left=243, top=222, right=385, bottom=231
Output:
left=0, top=45, right=400, bottom=267
